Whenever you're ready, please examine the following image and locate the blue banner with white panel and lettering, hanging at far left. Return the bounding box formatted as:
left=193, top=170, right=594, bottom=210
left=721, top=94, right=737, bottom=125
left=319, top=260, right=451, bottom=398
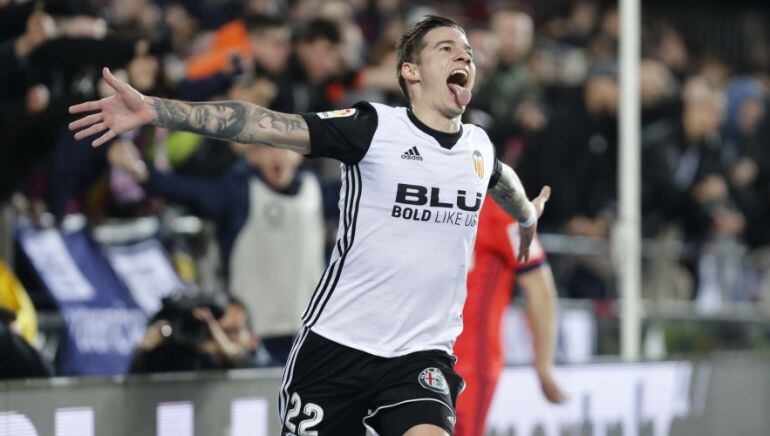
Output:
left=17, top=228, right=148, bottom=375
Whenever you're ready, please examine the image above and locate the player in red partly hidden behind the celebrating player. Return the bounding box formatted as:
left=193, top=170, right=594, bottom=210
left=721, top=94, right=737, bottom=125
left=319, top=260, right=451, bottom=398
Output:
left=454, top=200, right=566, bottom=436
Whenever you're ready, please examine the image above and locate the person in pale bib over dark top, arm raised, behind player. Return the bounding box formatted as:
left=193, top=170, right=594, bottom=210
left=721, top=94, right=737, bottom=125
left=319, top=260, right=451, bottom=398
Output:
left=110, top=135, right=324, bottom=364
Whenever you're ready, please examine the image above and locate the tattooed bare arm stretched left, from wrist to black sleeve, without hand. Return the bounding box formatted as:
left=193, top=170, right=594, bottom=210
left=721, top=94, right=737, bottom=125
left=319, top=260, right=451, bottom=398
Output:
left=147, top=97, right=310, bottom=153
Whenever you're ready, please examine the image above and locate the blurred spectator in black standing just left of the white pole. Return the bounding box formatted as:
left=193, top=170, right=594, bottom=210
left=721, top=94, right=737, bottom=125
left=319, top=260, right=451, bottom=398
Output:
left=517, top=64, right=618, bottom=299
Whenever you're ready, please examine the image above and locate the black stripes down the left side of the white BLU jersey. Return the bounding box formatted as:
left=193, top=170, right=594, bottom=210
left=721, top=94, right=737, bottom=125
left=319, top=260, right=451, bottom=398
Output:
left=302, top=165, right=361, bottom=327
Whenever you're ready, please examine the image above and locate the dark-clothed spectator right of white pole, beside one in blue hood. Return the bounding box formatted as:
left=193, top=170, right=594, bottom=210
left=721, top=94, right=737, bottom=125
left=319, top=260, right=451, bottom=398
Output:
left=643, top=78, right=744, bottom=244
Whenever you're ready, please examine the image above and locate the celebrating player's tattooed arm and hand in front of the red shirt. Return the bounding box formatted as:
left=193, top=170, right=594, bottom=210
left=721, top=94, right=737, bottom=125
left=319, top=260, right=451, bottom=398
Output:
left=489, top=163, right=551, bottom=262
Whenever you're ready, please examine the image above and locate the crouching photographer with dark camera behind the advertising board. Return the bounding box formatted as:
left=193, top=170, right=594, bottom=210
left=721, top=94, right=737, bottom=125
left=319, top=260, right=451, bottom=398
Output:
left=129, top=296, right=268, bottom=374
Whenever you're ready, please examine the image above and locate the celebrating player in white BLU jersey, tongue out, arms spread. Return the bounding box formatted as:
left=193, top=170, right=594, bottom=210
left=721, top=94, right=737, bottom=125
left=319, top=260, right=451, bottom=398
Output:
left=70, top=16, right=550, bottom=436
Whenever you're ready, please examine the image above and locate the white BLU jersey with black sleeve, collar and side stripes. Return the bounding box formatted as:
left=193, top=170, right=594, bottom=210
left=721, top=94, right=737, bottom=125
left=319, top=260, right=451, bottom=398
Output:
left=302, top=103, right=499, bottom=357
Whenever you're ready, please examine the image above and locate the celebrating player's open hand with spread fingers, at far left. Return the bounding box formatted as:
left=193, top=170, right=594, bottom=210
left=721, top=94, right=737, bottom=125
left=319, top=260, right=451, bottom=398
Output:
left=69, top=68, right=155, bottom=147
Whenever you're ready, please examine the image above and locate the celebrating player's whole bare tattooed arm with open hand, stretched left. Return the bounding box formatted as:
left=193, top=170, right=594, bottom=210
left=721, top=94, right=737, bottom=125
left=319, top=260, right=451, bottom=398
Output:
left=69, top=68, right=310, bottom=154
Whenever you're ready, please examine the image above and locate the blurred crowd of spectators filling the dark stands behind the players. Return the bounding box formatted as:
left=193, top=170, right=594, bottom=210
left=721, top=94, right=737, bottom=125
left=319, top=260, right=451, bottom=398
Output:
left=0, top=0, right=770, bottom=376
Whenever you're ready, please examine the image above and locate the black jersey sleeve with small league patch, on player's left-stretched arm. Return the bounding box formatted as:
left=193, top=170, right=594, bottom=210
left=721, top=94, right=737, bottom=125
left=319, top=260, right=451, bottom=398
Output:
left=301, top=102, right=377, bottom=165
